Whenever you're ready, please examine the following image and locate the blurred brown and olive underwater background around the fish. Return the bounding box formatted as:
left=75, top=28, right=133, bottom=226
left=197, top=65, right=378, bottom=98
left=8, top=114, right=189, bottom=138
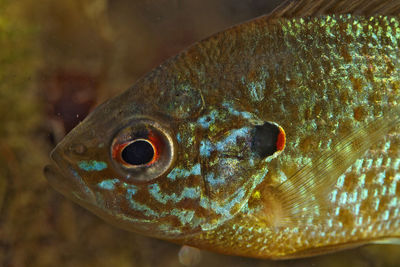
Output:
left=0, top=0, right=400, bottom=267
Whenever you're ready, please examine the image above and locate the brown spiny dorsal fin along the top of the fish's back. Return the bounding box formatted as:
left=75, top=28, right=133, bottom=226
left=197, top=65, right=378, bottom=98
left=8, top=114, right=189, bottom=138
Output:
left=269, top=0, right=400, bottom=18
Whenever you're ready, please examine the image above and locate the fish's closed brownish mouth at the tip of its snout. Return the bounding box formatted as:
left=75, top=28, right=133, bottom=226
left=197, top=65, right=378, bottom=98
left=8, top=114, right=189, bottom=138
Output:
left=44, top=147, right=96, bottom=206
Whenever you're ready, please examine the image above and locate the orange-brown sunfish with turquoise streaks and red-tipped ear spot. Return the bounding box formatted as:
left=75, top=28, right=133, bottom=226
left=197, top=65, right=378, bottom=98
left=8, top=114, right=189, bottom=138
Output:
left=44, top=0, right=400, bottom=259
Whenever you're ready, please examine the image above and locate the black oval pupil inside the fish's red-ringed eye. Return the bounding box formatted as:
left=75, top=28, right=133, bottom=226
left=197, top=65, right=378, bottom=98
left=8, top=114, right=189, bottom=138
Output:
left=121, top=140, right=154, bottom=165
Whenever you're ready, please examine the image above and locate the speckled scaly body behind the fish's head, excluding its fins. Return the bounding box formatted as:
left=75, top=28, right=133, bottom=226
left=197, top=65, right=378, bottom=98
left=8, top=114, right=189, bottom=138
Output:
left=167, top=15, right=400, bottom=257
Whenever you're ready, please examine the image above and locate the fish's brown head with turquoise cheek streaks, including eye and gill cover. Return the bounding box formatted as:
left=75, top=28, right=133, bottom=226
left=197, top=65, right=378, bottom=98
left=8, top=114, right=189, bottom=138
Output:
left=45, top=63, right=284, bottom=239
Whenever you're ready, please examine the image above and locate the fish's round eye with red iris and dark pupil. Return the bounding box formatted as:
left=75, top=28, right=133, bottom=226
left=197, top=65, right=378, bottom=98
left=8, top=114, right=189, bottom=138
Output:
left=111, top=119, right=174, bottom=182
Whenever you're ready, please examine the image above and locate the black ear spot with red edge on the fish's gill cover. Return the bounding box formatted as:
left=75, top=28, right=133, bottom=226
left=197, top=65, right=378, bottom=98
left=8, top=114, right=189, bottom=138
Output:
left=252, top=122, right=286, bottom=158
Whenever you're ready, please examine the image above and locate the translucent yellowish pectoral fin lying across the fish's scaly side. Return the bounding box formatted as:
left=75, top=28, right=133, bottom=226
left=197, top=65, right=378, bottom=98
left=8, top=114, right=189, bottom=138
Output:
left=276, top=105, right=400, bottom=224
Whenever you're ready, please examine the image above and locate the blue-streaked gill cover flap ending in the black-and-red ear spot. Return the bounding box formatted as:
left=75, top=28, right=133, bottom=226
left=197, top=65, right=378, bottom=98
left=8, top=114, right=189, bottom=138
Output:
left=200, top=122, right=285, bottom=221
